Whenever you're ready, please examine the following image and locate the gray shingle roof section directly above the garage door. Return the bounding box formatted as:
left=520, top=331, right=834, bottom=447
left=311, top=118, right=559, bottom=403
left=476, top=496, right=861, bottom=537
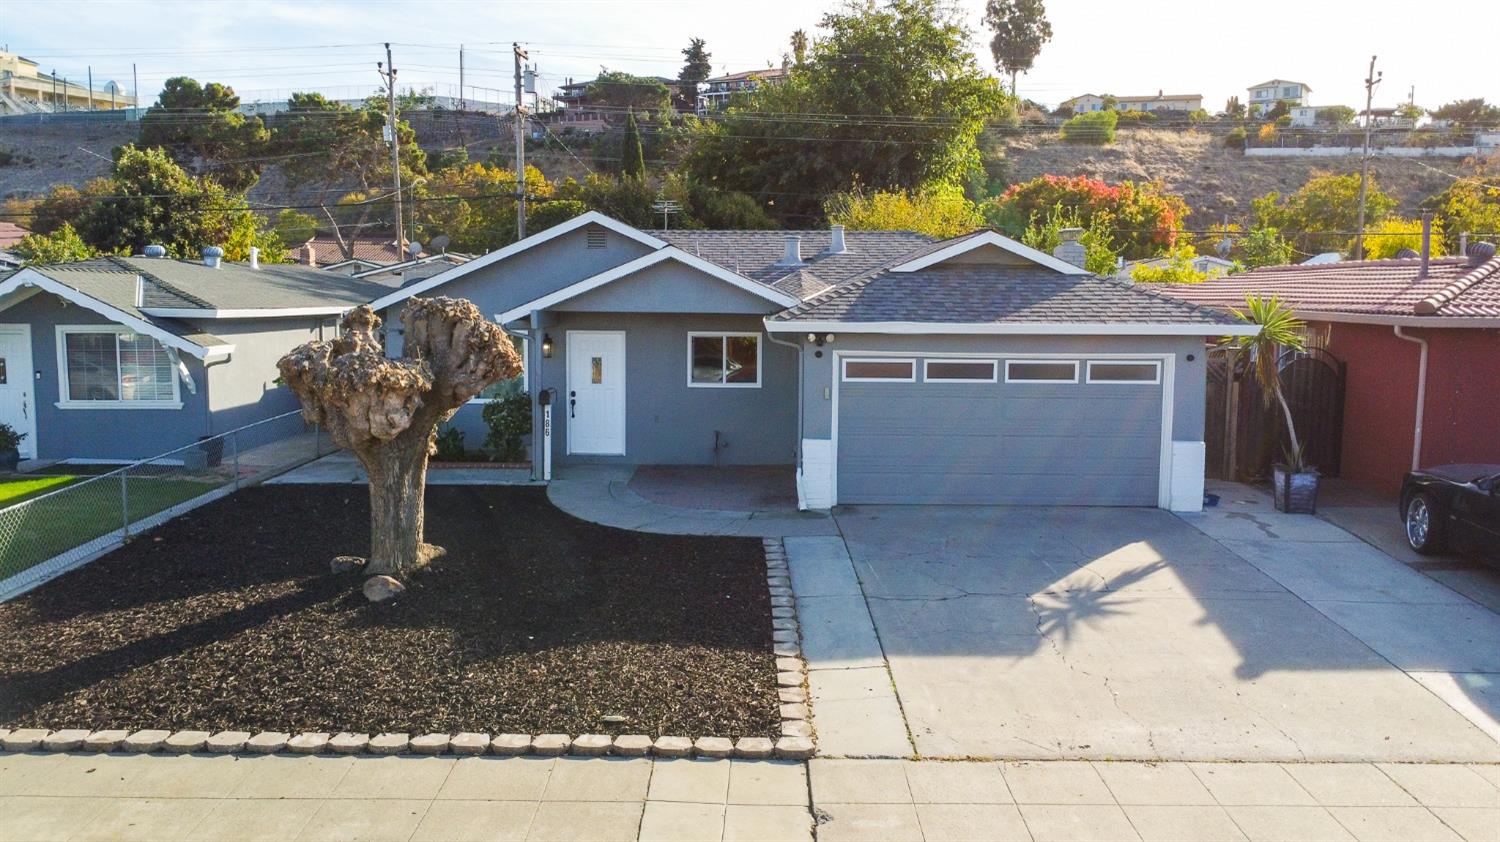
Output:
left=773, top=264, right=1238, bottom=327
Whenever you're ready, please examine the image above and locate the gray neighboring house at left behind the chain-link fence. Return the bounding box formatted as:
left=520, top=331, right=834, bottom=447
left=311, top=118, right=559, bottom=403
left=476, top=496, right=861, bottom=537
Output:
left=0, top=249, right=401, bottom=462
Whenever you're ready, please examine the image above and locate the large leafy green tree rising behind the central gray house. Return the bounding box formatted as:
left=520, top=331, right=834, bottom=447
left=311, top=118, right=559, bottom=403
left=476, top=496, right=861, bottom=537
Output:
left=686, top=0, right=1010, bottom=227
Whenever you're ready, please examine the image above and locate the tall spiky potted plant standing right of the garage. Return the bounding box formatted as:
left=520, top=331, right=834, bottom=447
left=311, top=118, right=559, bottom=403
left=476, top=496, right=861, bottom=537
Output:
left=1224, top=296, right=1319, bottom=515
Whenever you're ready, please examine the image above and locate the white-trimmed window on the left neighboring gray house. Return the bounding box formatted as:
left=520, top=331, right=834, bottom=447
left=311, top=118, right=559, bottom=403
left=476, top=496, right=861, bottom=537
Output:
left=57, top=324, right=183, bottom=410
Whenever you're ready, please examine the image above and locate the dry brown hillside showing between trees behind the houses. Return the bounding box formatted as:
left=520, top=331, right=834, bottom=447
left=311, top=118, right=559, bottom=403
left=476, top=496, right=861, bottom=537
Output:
left=0, top=116, right=1475, bottom=227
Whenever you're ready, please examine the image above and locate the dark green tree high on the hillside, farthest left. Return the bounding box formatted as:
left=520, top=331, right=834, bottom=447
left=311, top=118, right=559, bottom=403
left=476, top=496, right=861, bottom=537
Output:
left=135, top=77, right=270, bottom=192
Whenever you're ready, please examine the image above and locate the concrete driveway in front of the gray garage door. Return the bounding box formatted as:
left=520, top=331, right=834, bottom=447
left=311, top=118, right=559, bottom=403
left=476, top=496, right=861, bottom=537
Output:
left=828, top=486, right=1500, bottom=761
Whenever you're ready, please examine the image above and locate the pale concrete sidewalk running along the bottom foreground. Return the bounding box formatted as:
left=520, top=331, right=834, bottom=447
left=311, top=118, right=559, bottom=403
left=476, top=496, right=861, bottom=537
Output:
left=0, top=753, right=1500, bottom=842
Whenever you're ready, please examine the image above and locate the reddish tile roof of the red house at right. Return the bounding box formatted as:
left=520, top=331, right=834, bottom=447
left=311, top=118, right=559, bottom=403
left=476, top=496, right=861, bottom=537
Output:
left=1163, top=257, right=1500, bottom=318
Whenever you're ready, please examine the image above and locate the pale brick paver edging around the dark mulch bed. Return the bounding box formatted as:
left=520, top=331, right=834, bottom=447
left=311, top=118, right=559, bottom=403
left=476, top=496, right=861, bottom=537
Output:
left=0, top=539, right=816, bottom=759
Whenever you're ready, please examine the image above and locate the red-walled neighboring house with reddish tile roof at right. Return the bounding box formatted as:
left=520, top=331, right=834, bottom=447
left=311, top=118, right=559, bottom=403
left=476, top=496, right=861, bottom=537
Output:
left=1161, top=243, right=1500, bottom=494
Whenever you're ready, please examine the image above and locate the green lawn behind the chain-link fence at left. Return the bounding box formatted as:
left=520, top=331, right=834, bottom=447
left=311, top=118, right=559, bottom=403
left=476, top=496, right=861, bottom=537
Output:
left=0, top=473, right=231, bottom=578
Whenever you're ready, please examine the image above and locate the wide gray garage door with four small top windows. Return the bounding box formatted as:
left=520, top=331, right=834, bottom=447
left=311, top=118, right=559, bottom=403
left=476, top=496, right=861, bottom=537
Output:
left=836, top=357, right=1163, bottom=506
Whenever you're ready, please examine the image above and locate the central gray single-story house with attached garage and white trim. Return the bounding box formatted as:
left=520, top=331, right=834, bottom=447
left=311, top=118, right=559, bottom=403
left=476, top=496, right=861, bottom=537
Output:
left=372, top=213, right=1254, bottom=510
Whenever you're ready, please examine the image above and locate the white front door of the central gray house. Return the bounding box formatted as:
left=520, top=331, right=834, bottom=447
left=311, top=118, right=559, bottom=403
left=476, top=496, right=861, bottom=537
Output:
left=566, top=330, right=626, bottom=456
